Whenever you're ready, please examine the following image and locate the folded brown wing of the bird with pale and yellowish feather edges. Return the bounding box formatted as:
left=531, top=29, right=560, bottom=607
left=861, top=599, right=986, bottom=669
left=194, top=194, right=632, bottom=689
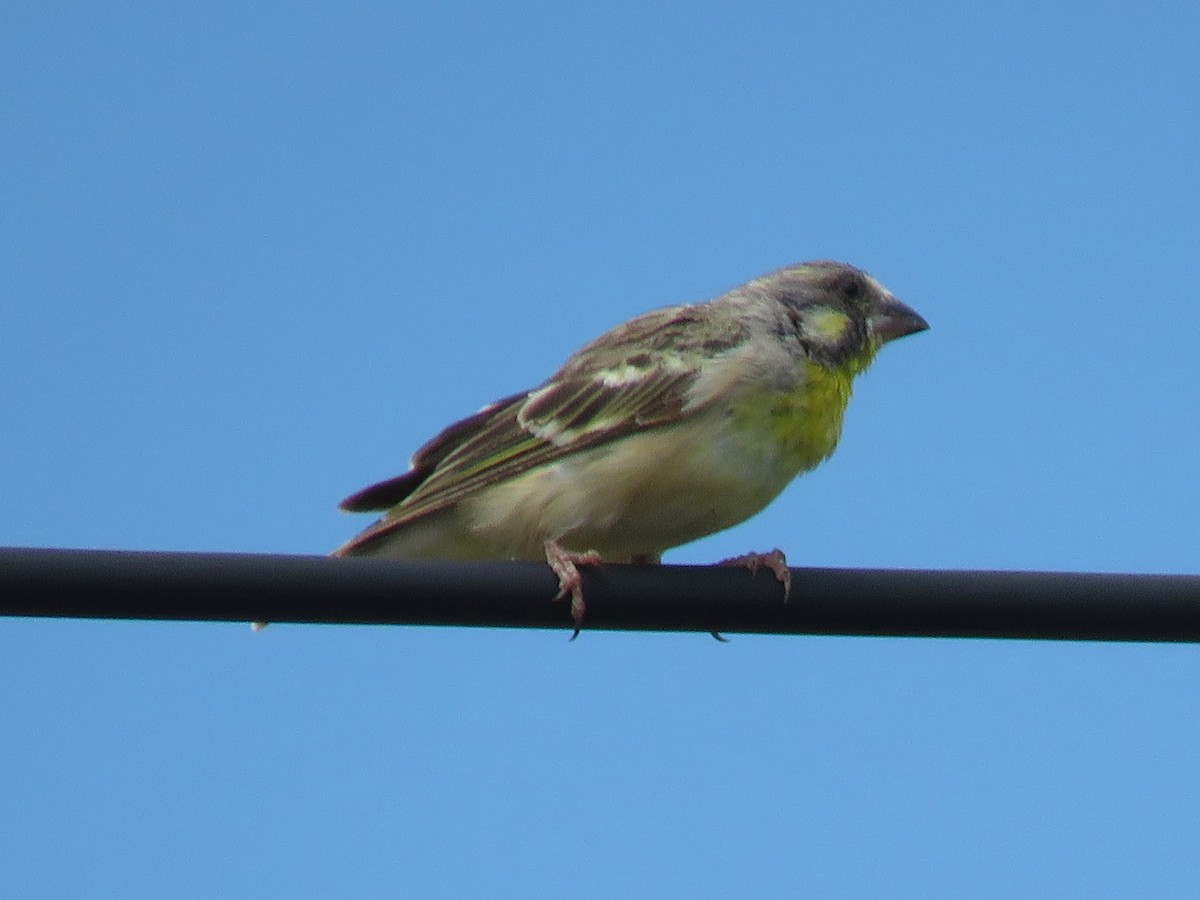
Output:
left=342, top=306, right=746, bottom=550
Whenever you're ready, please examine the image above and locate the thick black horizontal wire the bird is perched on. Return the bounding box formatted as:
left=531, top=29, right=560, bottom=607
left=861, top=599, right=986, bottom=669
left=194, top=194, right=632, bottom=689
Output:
left=0, top=548, right=1200, bottom=641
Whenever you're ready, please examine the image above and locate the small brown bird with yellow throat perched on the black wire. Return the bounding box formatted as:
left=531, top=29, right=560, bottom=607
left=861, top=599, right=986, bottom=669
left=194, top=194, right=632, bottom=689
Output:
left=334, top=262, right=929, bottom=630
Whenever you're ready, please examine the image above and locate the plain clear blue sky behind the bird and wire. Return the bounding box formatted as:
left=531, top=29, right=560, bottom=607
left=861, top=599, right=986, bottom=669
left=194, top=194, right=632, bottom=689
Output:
left=0, top=1, right=1200, bottom=898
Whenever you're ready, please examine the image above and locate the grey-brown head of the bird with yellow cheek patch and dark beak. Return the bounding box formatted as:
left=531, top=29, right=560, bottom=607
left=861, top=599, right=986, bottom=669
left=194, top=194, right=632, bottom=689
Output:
left=748, top=260, right=929, bottom=373
